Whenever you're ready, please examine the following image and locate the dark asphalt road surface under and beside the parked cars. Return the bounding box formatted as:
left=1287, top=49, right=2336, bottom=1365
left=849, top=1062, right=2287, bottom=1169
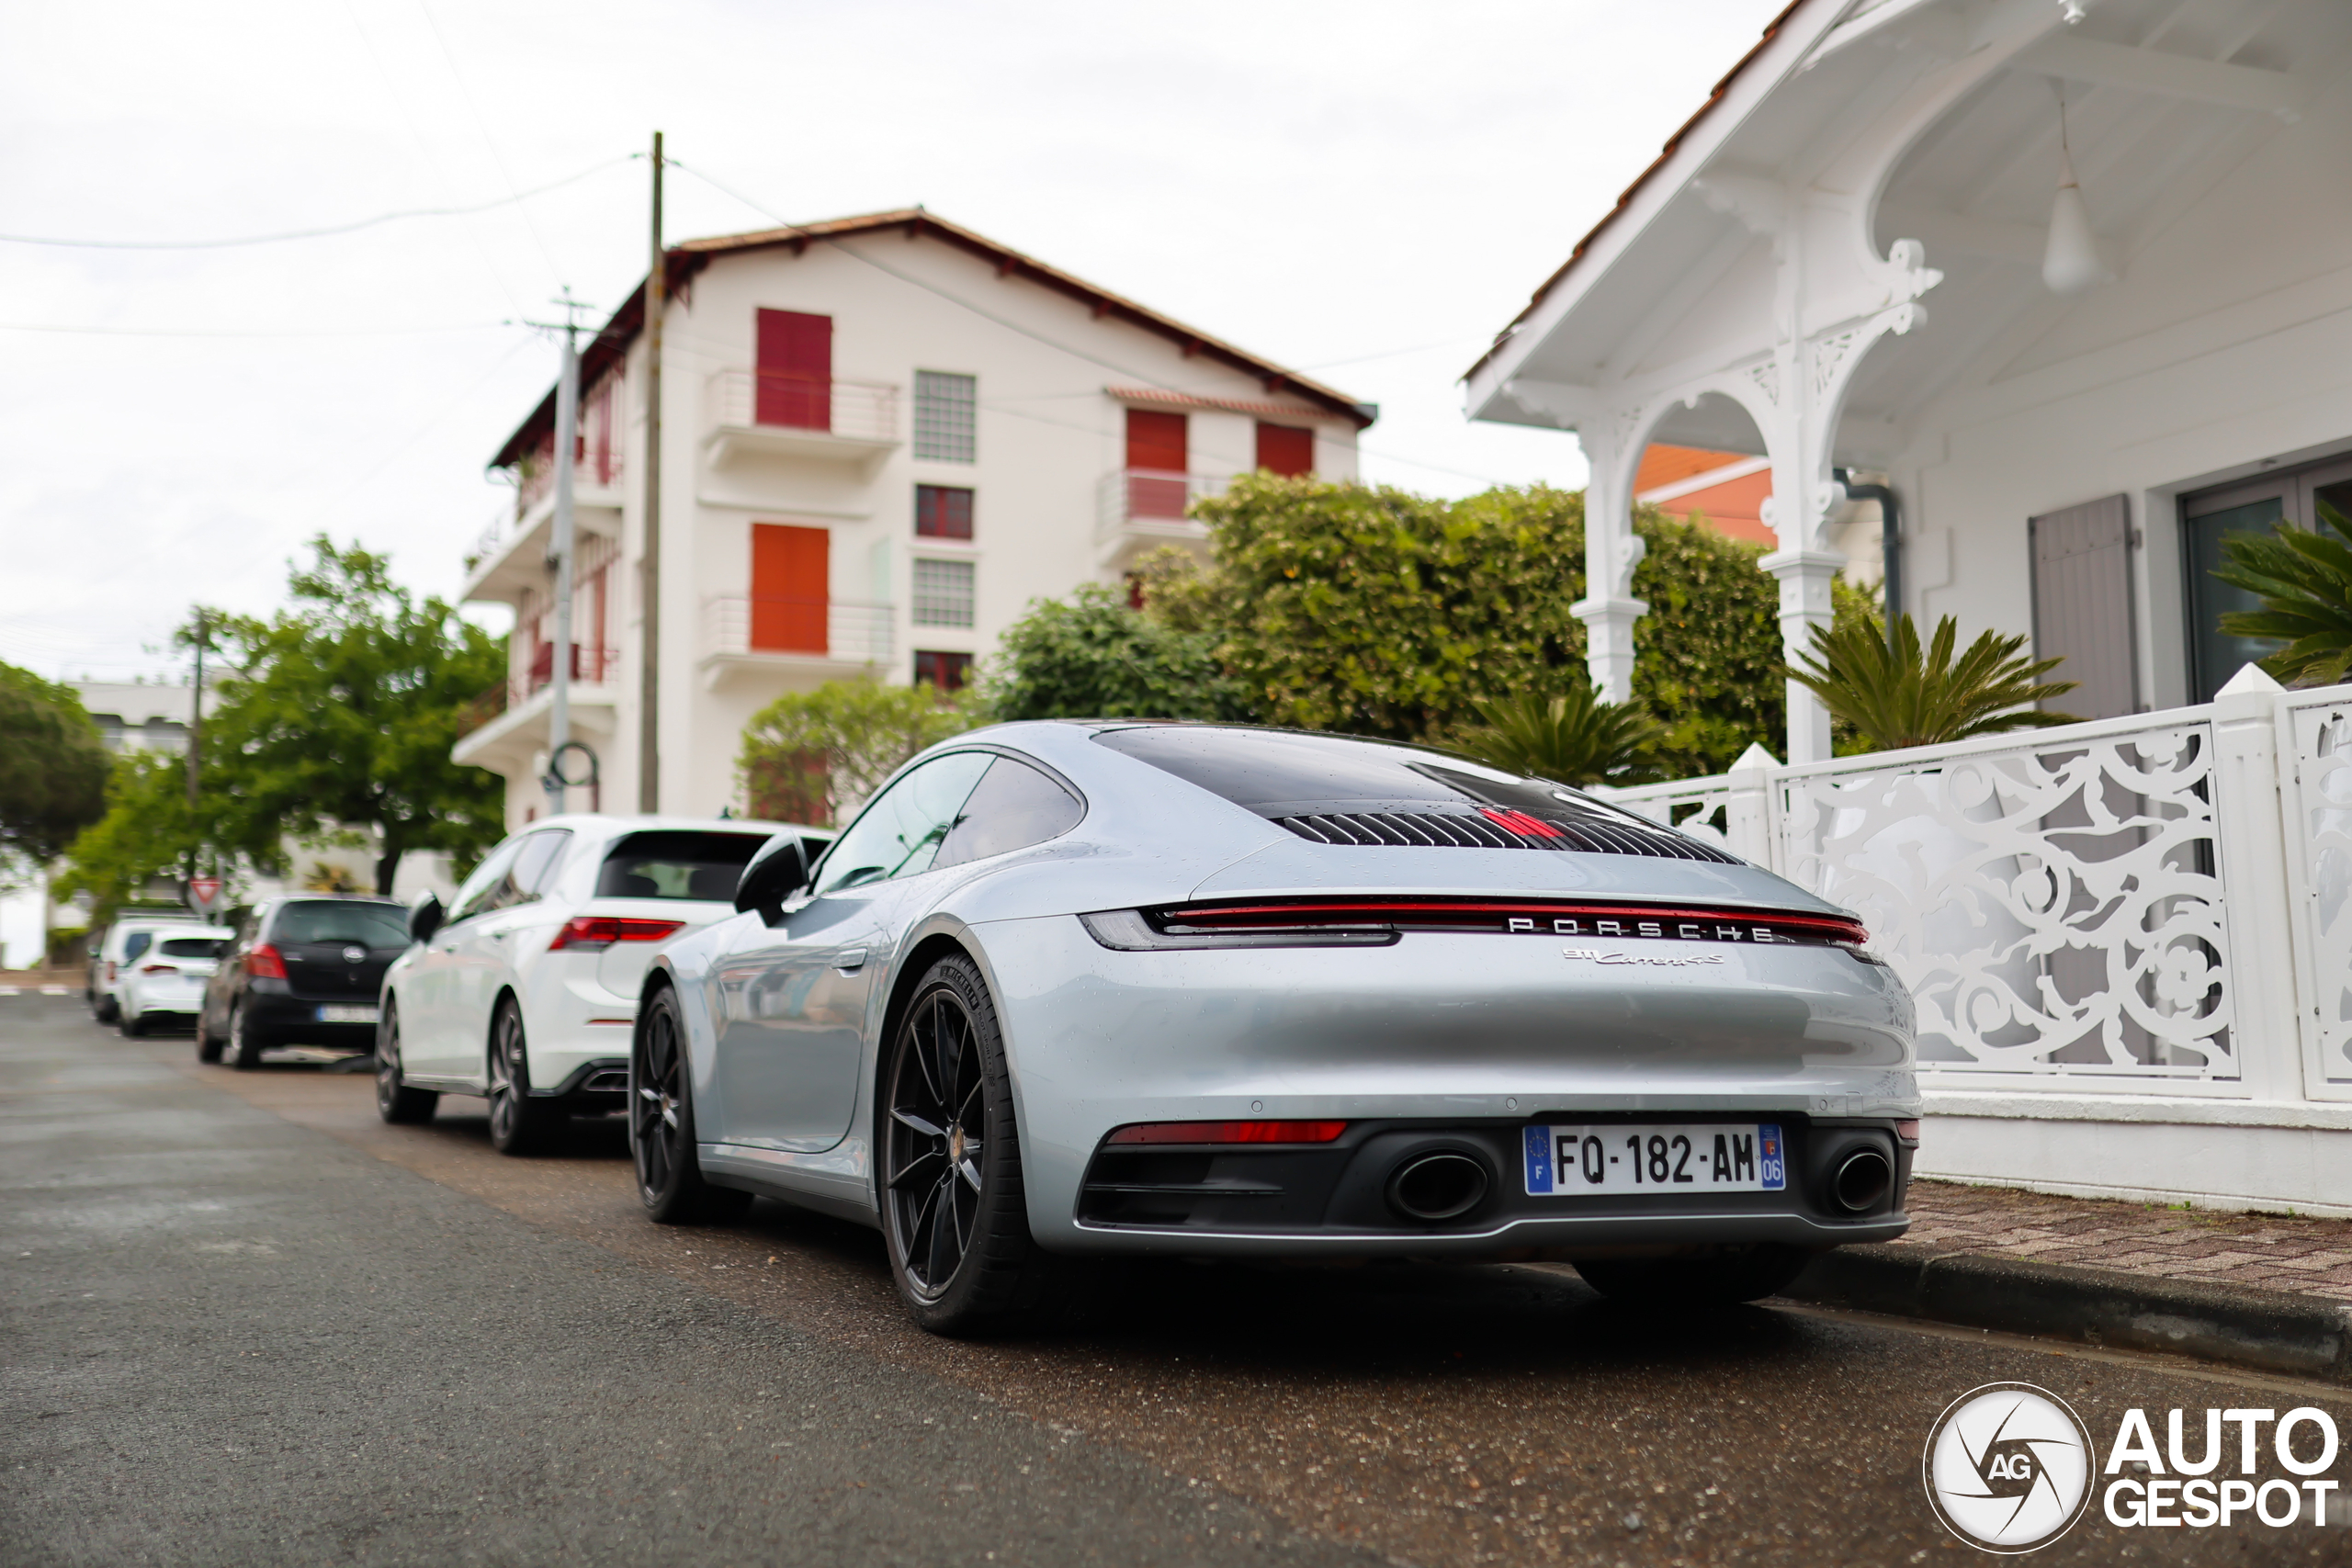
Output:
left=0, top=997, right=2352, bottom=1568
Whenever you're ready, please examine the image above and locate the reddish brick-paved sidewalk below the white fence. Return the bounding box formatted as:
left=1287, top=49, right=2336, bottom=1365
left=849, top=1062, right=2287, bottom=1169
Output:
left=1903, top=1182, right=2352, bottom=1303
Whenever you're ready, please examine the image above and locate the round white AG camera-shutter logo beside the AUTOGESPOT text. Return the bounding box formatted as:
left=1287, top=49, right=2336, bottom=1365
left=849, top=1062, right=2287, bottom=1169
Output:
left=1922, top=1382, right=2093, bottom=1556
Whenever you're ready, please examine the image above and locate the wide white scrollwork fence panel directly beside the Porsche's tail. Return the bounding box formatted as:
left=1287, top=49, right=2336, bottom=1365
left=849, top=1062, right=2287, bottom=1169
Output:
left=1781, top=722, right=2239, bottom=1079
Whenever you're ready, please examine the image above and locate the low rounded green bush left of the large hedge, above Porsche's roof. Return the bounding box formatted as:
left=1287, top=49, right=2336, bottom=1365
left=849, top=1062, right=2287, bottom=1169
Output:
left=978, top=583, right=1247, bottom=719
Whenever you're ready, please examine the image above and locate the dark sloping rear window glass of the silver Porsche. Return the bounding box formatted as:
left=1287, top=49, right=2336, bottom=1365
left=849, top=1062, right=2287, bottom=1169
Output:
left=1093, top=724, right=1651, bottom=828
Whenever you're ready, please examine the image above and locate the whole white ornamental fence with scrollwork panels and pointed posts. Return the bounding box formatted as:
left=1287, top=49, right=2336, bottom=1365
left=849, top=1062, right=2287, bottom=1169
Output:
left=1604, top=665, right=2352, bottom=1114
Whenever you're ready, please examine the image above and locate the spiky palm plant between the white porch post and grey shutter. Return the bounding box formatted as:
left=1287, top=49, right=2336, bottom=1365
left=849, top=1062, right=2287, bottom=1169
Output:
left=1790, top=616, right=2079, bottom=752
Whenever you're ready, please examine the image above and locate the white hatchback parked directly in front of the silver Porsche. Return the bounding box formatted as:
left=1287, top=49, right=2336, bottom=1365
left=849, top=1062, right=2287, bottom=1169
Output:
left=377, top=816, right=832, bottom=1155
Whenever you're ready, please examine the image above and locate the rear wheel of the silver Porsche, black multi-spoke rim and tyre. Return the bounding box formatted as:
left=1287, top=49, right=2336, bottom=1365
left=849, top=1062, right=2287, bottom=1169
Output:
left=875, top=952, right=1093, bottom=1336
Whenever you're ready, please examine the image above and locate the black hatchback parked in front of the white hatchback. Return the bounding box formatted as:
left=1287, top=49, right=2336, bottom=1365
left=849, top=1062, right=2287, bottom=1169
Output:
left=195, top=894, right=409, bottom=1067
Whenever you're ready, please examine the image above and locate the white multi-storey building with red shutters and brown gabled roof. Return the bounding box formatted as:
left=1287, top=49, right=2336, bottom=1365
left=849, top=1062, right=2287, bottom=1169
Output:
left=454, top=209, right=1376, bottom=825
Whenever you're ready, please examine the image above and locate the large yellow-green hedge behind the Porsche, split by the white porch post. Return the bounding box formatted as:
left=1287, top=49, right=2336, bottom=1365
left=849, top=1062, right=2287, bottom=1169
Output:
left=1185, top=475, right=1785, bottom=776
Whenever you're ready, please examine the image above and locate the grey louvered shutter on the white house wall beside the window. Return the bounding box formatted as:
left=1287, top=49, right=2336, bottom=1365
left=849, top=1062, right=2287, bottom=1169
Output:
left=2025, top=496, right=2141, bottom=719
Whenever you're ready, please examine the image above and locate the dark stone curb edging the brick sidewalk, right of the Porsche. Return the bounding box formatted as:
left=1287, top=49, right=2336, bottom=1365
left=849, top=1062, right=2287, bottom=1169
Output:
left=1782, top=1241, right=2352, bottom=1384
